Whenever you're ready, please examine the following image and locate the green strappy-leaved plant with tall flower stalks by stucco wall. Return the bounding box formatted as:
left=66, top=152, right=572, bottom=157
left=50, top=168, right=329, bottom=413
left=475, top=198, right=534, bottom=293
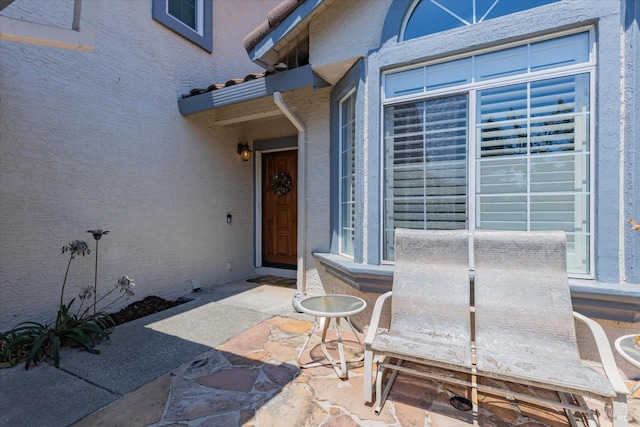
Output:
left=0, top=233, right=135, bottom=369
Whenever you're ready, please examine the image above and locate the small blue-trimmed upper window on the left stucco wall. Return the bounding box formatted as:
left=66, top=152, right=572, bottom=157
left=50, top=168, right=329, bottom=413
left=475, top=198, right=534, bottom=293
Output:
left=151, top=0, right=213, bottom=52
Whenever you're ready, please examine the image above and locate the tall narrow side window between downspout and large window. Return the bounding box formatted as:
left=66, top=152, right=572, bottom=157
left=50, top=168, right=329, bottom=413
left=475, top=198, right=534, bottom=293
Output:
left=340, top=93, right=356, bottom=256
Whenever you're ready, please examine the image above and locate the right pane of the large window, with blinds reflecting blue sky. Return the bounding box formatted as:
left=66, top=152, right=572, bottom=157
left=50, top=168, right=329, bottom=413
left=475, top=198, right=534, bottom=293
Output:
left=475, top=74, right=590, bottom=273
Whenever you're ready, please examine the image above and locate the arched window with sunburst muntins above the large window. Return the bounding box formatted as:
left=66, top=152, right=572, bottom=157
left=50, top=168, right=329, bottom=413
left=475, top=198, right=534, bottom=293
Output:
left=402, top=0, right=559, bottom=40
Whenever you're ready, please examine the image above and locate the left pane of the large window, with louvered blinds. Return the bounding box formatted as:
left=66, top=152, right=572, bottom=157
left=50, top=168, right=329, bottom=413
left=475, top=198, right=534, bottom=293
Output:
left=384, top=95, right=468, bottom=259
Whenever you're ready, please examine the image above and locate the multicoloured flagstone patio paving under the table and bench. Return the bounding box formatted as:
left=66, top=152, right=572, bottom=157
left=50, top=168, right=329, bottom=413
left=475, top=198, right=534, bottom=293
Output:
left=74, top=317, right=640, bottom=427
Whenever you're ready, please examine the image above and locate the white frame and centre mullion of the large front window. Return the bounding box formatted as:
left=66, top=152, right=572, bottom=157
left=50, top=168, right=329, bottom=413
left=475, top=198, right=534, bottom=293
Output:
left=379, top=26, right=597, bottom=279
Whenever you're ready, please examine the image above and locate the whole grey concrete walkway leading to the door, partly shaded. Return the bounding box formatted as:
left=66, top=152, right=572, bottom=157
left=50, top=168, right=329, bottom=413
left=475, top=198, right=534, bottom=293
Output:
left=0, top=281, right=307, bottom=427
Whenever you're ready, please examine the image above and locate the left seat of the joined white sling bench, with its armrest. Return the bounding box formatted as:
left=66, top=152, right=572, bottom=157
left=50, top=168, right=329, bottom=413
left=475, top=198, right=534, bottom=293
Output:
left=364, top=229, right=472, bottom=413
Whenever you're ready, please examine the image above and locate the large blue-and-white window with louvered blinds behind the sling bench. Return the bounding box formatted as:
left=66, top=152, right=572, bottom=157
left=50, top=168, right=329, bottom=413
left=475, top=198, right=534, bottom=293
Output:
left=382, top=32, right=594, bottom=275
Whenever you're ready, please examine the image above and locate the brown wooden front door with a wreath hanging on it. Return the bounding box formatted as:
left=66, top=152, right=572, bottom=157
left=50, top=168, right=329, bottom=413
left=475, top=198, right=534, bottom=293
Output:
left=262, top=150, right=298, bottom=268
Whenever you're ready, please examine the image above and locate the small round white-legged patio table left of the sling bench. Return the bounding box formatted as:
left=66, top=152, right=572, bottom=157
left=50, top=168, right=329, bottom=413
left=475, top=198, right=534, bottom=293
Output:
left=297, top=295, right=367, bottom=378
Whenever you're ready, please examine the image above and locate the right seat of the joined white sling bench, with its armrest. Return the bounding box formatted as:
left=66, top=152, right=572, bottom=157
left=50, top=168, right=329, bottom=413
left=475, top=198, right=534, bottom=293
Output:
left=473, top=230, right=628, bottom=426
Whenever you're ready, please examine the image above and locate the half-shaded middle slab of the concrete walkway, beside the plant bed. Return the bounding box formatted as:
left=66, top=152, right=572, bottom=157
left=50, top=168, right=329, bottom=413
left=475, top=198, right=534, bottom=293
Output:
left=60, top=300, right=271, bottom=396
